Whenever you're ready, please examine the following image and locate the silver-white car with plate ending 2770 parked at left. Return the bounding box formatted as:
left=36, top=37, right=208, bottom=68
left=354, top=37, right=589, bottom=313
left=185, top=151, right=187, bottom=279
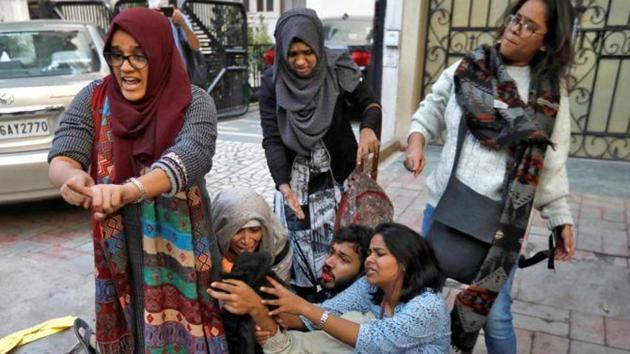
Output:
left=0, top=20, right=109, bottom=203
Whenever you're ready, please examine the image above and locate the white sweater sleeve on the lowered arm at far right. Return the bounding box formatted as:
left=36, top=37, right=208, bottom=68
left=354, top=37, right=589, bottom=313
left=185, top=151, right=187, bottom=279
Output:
left=534, top=89, right=573, bottom=229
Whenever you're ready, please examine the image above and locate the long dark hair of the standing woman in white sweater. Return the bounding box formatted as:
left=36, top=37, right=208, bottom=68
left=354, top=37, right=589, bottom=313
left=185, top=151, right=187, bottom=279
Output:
left=497, top=0, right=575, bottom=89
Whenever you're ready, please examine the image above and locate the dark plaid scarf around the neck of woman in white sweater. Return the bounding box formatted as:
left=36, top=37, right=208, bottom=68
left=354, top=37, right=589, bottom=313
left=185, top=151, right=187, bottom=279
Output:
left=451, top=46, right=559, bottom=351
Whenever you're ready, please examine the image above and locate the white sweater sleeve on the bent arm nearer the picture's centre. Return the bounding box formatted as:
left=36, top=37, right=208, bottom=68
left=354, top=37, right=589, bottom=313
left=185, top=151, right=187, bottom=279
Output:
left=407, top=61, right=459, bottom=143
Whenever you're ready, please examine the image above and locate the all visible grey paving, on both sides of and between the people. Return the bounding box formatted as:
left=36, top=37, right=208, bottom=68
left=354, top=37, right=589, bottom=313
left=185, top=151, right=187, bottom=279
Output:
left=0, top=106, right=630, bottom=354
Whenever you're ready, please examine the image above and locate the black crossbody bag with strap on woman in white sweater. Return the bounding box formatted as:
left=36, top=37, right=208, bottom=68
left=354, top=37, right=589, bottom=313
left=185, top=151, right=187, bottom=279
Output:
left=426, top=117, right=503, bottom=284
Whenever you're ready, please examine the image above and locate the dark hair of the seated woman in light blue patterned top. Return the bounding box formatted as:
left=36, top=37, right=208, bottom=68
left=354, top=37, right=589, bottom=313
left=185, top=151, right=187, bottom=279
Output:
left=372, top=223, right=445, bottom=305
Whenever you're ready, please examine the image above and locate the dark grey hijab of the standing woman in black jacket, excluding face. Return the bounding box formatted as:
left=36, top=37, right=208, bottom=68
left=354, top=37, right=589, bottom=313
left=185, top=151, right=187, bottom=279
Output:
left=273, top=8, right=361, bottom=156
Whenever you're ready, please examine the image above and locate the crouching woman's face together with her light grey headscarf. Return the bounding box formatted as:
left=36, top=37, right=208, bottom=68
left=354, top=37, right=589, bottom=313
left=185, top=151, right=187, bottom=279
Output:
left=211, top=188, right=292, bottom=281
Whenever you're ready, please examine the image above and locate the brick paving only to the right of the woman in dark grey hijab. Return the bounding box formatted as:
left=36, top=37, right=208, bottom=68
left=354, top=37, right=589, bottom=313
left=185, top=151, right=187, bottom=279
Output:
left=379, top=146, right=630, bottom=354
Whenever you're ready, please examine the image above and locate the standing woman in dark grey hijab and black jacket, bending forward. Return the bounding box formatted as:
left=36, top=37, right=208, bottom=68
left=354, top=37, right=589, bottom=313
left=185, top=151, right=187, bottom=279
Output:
left=258, top=9, right=381, bottom=298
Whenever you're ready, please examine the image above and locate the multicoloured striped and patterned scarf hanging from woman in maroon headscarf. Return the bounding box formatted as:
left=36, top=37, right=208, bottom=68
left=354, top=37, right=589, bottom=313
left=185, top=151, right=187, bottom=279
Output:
left=87, top=85, right=228, bottom=354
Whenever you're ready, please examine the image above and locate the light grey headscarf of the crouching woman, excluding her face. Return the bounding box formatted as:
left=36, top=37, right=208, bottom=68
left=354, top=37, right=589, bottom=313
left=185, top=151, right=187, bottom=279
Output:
left=211, top=188, right=292, bottom=280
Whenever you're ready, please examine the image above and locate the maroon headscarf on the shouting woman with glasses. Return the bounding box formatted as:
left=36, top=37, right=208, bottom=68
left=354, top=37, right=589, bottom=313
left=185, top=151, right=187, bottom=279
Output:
left=103, top=8, right=192, bottom=183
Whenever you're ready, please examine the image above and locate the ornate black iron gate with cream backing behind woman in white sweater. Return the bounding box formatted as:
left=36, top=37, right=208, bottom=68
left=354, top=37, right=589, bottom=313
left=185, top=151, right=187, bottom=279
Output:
left=422, top=0, right=630, bottom=161
